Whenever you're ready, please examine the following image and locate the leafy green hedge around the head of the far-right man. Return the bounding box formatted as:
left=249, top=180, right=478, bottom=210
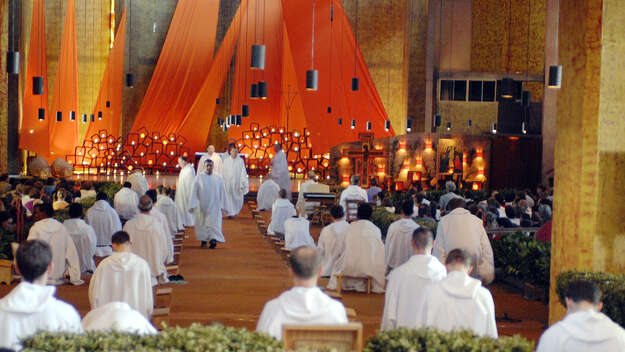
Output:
left=556, top=270, right=625, bottom=327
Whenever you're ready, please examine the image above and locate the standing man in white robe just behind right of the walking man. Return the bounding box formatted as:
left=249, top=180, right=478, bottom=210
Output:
left=222, top=143, right=250, bottom=218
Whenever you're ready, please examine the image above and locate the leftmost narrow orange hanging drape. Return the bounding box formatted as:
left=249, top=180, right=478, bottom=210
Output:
left=19, top=0, right=52, bottom=156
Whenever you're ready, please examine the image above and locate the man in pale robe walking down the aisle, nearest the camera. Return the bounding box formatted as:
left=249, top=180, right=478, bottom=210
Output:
left=189, top=159, right=226, bottom=249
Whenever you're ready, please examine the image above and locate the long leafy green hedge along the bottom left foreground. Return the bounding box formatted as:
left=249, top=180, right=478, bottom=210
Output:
left=23, top=324, right=283, bottom=352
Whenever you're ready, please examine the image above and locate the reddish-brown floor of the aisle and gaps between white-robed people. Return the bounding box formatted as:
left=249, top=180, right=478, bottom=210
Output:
left=0, top=202, right=547, bottom=340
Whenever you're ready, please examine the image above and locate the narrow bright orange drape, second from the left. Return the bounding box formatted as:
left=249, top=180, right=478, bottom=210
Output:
left=48, top=0, right=79, bottom=160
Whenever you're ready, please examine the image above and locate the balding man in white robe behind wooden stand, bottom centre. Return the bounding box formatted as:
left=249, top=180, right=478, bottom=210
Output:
left=256, top=247, right=348, bottom=340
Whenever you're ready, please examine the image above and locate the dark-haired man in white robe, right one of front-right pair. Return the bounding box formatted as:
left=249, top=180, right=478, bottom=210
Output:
left=417, top=249, right=497, bottom=338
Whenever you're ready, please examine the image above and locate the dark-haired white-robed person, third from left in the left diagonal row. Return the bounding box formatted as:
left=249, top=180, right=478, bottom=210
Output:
left=87, top=192, right=122, bottom=257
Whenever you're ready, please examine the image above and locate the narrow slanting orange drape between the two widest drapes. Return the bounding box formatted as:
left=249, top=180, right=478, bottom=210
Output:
left=176, top=0, right=247, bottom=152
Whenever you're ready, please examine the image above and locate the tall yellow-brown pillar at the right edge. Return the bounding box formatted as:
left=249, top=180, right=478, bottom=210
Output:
left=549, top=0, right=625, bottom=323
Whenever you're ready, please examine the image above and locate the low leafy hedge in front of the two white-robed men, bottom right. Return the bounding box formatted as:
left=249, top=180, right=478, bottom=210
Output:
left=364, top=328, right=534, bottom=352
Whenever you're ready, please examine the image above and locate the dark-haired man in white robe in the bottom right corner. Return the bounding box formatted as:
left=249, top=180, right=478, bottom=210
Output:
left=536, top=280, right=625, bottom=352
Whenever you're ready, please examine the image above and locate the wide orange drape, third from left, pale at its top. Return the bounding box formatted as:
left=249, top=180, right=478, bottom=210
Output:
left=132, top=0, right=219, bottom=133
